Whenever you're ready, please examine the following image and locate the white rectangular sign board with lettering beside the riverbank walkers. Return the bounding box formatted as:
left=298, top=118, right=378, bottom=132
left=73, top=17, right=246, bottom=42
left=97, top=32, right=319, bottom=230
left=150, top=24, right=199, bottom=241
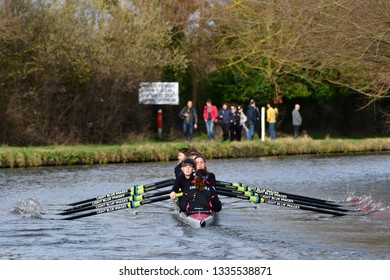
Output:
left=139, top=82, right=179, bottom=105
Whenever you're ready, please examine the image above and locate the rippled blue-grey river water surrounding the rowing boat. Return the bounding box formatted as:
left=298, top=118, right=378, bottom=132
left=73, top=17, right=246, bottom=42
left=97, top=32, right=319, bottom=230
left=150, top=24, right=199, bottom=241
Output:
left=0, top=154, right=390, bottom=260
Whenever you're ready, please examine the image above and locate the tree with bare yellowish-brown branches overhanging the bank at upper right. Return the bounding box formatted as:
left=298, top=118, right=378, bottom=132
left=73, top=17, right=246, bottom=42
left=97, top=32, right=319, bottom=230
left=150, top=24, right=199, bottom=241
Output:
left=210, top=0, right=390, bottom=131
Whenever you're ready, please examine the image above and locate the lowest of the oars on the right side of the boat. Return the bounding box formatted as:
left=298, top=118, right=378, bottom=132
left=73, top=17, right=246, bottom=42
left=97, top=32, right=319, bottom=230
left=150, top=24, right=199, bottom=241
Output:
left=217, top=187, right=349, bottom=216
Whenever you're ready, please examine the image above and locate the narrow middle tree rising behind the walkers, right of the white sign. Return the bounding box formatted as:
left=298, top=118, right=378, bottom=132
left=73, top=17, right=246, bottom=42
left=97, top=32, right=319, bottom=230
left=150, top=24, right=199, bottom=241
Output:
left=160, top=0, right=218, bottom=108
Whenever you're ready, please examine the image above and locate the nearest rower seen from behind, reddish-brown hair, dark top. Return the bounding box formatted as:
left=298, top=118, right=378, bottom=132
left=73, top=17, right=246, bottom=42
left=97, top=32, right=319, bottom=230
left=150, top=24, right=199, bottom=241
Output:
left=179, top=169, right=222, bottom=214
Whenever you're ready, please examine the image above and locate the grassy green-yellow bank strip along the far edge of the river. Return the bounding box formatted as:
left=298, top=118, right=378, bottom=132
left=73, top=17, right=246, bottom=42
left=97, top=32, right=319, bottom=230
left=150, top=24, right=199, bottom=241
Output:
left=0, top=138, right=390, bottom=168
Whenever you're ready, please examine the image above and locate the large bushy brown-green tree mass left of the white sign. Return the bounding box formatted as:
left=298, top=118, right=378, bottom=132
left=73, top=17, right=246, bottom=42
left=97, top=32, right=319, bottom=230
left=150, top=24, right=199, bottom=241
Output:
left=0, top=0, right=187, bottom=145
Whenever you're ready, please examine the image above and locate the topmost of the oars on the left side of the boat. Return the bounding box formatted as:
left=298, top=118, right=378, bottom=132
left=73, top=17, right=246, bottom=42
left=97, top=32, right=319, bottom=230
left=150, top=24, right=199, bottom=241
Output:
left=65, top=180, right=174, bottom=211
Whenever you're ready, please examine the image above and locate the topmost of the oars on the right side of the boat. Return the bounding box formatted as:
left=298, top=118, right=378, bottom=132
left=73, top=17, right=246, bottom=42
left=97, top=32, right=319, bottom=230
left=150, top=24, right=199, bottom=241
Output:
left=216, top=181, right=342, bottom=207
